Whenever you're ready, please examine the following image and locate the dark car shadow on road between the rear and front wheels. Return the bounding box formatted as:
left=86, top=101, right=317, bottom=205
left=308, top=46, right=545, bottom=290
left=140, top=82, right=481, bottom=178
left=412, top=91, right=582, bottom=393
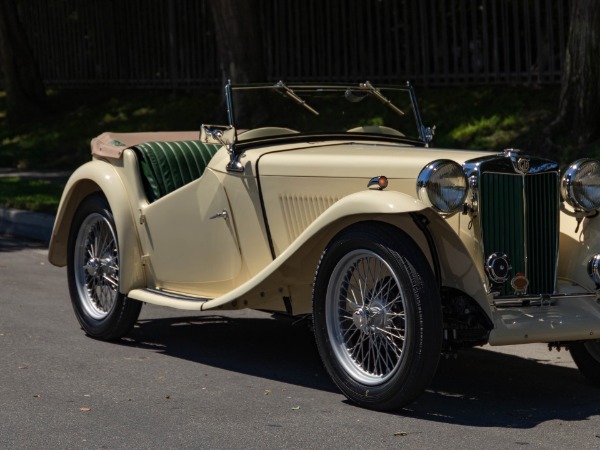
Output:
left=121, top=315, right=336, bottom=392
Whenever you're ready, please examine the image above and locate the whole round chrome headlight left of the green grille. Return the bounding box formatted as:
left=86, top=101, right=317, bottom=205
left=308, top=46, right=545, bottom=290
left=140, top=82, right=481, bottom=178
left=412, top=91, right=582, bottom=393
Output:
left=417, top=159, right=467, bottom=214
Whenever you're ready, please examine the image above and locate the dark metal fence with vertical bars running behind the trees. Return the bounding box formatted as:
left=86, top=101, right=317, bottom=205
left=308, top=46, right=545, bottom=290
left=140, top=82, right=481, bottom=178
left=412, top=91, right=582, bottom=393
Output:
left=19, top=0, right=569, bottom=88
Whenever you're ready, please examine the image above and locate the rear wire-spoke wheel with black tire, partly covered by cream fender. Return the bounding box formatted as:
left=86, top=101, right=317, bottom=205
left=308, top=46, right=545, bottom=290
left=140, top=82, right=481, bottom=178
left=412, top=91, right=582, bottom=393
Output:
left=67, top=194, right=142, bottom=340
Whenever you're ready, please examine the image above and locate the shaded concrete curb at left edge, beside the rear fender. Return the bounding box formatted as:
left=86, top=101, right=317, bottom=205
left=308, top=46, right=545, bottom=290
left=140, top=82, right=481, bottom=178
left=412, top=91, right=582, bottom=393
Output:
left=0, top=208, right=55, bottom=244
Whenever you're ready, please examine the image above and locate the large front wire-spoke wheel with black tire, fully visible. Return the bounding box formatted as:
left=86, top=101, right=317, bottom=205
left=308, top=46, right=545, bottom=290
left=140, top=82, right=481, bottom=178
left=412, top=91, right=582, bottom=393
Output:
left=313, top=222, right=442, bottom=411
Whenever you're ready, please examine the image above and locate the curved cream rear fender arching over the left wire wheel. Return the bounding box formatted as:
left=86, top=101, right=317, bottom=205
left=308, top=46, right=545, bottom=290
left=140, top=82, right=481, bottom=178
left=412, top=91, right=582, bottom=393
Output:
left=48, top=160, right=145, bottom=293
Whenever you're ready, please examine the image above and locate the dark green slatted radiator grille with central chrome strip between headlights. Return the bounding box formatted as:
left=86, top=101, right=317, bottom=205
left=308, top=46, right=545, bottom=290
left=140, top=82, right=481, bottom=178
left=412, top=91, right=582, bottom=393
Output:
left=479, top=172, right=559, bottom=295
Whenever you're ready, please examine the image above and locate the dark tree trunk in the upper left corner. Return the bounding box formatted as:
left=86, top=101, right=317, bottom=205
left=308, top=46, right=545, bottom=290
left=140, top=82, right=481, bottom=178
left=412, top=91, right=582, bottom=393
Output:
left=0, top=0, right=47, bottom=125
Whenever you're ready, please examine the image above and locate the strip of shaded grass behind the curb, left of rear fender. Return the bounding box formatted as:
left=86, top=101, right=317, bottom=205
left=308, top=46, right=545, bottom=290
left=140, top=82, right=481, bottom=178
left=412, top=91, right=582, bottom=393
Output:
left=0, top=177, right=64, bottom=214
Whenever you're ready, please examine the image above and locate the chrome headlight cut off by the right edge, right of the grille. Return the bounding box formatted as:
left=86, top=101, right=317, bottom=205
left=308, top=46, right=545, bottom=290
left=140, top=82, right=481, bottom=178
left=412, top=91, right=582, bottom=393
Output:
left=560, top=158, right=600, bottom=211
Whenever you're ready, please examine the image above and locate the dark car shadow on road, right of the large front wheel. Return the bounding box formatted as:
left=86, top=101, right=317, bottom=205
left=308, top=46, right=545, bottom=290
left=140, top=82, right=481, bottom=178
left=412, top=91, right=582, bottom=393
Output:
left=400, top=349, right=600, bottom=428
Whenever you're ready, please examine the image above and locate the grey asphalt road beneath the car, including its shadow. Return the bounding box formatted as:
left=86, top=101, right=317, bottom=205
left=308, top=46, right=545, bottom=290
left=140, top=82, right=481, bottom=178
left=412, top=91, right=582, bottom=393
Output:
left=0, top=237, right=600, bottom=449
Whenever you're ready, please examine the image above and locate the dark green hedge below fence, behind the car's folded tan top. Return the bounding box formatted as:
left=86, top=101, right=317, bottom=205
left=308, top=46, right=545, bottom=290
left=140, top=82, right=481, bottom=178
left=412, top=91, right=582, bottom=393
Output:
left=0, top=89, right=220, bottom=170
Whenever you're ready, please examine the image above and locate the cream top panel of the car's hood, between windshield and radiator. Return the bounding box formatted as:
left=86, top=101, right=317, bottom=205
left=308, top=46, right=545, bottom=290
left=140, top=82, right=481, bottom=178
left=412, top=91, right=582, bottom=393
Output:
left=259, top=142, right=495, bottom=179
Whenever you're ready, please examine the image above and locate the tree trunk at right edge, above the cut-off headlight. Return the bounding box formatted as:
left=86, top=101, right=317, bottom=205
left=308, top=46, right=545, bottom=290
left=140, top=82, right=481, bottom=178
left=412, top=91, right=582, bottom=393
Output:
left=549, top=0, right=600, bottom=147
